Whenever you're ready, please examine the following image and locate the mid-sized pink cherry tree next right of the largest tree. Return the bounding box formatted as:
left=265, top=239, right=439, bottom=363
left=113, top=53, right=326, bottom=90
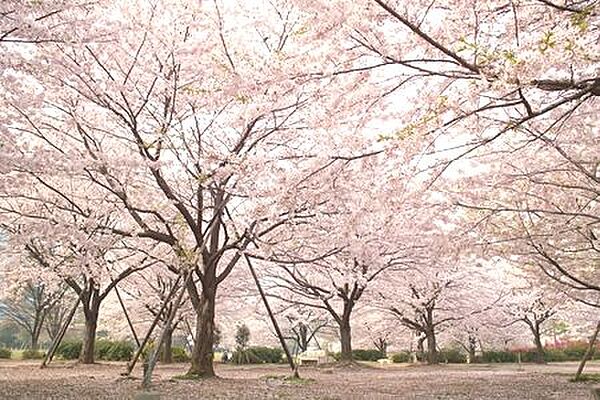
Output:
left=260, top=153, right=431, bottom=361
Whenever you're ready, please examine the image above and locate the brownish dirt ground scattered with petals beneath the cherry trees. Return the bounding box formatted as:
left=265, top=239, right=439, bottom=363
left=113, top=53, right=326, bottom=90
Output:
left=0, top=360, right=600, bottom=400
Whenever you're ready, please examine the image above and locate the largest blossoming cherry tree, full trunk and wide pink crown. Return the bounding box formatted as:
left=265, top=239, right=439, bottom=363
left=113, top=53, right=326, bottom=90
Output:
left=2, top=0, right=372, bottom=376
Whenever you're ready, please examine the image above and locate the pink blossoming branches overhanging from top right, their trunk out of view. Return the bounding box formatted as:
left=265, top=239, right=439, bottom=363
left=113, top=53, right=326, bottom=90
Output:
left=298, top=0, right=600, bottom=173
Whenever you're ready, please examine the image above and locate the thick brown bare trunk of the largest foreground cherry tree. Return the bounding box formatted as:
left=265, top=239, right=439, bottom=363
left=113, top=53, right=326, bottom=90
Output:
left=187, top=285, right=217, bottom=378
